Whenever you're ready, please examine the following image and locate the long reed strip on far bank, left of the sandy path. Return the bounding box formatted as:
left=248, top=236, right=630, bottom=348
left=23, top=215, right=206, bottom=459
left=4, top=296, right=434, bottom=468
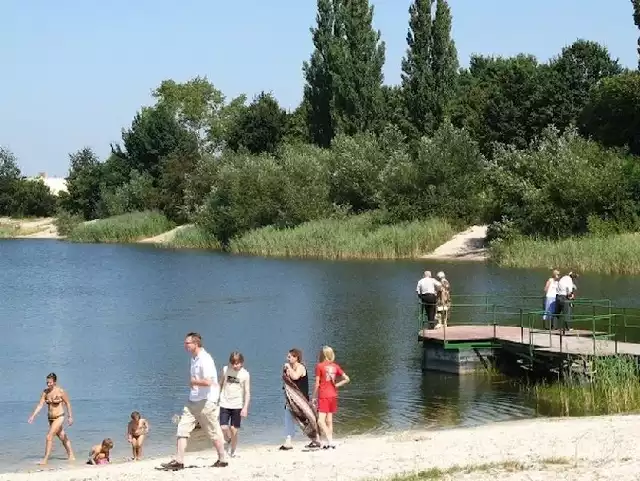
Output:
left=229, top=213, right=455, bottom=259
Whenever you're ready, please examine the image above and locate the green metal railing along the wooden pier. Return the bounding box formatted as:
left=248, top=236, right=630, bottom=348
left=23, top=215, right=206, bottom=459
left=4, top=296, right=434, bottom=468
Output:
left=418, top=295, right=640, bottom=354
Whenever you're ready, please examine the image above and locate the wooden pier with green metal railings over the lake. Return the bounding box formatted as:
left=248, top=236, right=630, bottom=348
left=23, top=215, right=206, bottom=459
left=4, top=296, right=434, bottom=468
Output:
left=418, top=298, right=640, bottom=374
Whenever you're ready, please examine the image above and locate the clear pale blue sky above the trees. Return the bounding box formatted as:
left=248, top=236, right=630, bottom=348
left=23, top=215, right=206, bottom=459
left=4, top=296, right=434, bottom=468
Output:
left=0, top=0, right=638, bottom=176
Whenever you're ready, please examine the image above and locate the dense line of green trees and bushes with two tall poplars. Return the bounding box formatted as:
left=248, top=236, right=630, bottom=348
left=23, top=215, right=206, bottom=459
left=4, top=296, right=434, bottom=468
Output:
left=0, top=0, right=640, bottom=242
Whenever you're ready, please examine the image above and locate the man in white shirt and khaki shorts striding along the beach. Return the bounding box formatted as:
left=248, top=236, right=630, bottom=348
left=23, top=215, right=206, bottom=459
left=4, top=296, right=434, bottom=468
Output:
left=162, top=332, right=228, bottom=471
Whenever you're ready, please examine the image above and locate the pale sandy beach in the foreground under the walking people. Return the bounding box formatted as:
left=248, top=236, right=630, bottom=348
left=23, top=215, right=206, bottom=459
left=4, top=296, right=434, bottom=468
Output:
left=7, top=415, right=640, bottom=481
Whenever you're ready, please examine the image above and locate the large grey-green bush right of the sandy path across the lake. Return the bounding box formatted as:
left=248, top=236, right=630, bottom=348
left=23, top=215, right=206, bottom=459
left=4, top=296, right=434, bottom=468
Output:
left=489, top=129, right=638, bottom=238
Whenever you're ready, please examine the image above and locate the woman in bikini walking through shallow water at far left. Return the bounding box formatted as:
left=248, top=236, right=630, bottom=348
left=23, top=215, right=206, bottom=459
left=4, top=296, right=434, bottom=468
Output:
left=29, top=373, right=75, bottom=464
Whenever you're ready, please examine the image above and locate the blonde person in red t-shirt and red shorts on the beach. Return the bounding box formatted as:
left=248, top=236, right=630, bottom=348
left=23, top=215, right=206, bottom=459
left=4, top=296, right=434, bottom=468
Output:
left=313, top=346, right=350, bottom=449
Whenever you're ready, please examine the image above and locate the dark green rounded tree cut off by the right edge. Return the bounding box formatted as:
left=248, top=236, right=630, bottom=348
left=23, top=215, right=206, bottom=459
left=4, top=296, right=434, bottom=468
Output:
left=580, top=71, right=640, bottom=155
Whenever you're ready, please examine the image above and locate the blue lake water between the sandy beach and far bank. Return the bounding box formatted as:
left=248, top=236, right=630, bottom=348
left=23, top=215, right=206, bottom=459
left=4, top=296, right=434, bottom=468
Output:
left=0, top=240, right=640, bottom=471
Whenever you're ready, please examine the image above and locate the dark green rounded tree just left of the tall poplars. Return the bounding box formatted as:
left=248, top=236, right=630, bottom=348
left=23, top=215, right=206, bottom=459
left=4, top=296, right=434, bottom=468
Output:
left=227, top=92, right=288, bottom=154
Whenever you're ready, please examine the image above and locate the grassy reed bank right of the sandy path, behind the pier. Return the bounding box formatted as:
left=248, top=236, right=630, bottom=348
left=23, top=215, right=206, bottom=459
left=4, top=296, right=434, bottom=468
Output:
left=491, top=234, right=640, bottom=274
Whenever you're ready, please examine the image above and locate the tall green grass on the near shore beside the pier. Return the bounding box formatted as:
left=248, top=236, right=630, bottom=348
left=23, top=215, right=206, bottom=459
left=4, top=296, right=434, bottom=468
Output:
left=530, top=355, right=640, bottom=416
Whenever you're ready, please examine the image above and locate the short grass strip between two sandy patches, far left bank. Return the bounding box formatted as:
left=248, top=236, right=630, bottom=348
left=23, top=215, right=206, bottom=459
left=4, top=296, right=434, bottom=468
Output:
left=67, top=211, right=175, bottom=243
